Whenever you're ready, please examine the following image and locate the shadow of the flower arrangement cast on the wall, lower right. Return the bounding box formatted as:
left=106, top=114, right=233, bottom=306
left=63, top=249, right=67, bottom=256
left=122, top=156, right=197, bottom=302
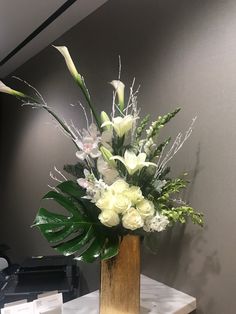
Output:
left=142, top=144, right=221, bottom=314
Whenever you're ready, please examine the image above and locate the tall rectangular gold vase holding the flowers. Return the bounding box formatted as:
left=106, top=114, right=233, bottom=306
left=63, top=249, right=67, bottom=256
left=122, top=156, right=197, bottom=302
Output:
left=100, top=235, right=140, bottom=314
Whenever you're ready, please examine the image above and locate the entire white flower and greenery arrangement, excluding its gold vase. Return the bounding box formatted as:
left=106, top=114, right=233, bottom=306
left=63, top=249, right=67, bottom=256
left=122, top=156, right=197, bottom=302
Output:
left=0, top=47, right=203, bottom=262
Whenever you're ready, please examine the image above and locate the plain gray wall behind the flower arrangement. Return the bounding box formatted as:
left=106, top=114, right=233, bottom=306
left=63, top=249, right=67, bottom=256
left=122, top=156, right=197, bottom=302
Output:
left=0, top=0, right=236, bottom=314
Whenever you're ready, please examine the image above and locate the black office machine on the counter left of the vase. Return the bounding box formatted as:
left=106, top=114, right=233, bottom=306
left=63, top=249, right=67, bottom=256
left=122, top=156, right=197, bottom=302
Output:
left=1, top=255, right=79, bottom=304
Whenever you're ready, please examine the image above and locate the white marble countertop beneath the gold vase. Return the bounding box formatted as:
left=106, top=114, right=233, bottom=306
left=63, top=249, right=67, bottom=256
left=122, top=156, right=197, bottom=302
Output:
left=63, top=275, right=196, bottom=314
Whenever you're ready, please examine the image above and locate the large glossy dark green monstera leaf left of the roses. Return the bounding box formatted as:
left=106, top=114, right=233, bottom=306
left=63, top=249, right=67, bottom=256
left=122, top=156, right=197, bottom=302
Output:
left=33, top=181, right=119, bottom=262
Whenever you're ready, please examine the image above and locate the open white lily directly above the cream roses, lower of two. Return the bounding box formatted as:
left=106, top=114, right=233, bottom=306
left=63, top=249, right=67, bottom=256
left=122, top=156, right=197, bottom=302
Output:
left=110, top=150, right=157, bottom=175
